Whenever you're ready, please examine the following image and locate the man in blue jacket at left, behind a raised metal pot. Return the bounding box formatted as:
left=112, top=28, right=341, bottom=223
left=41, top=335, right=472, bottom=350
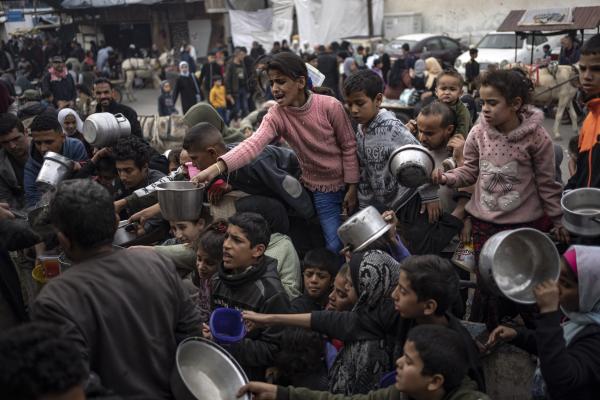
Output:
left=23, top=112, right=88, bottom=207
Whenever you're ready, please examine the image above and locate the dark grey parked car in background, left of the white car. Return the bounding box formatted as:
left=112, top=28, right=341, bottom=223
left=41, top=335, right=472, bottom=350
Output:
left=386, top=33, right=467, bottom=66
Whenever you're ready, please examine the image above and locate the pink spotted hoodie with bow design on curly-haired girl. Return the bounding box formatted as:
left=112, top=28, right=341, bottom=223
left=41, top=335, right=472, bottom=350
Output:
left=444, top=106, right=562, bottom=226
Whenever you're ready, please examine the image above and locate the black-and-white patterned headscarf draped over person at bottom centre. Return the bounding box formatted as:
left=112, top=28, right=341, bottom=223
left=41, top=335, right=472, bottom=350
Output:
left=329, top=250, right=400, bottom=396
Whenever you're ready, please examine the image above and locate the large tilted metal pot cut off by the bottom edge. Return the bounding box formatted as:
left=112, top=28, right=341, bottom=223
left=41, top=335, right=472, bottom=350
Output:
left=171, top=337, right=250, bottom=400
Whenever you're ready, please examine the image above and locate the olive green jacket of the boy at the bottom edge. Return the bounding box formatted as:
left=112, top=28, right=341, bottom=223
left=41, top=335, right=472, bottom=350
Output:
left=277, top=378, right=490, bottom=400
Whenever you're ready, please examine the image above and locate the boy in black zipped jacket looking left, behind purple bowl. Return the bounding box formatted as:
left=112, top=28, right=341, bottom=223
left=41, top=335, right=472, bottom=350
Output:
left=211, top=213, right=289, bottom=380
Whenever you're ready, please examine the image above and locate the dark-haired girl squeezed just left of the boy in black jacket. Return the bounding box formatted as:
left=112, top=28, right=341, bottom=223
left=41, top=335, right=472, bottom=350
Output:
left=192, top=220, right=227, bottom=323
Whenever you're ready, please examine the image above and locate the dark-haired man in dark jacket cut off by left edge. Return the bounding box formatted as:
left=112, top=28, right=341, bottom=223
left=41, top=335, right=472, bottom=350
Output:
left=0, top=113, right=30, bottom=209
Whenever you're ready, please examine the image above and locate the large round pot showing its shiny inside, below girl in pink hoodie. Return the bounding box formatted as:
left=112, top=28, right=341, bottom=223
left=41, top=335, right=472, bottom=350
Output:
left=479, top=228, right=560, bottom=304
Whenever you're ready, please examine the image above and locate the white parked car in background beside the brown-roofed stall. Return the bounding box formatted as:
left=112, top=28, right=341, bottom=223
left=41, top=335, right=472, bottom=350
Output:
left=454, top=32, right=562, bottom=76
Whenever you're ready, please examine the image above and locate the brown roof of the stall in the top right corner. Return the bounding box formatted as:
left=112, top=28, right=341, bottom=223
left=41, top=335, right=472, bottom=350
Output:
left=497, top=6, right=600, bottom=32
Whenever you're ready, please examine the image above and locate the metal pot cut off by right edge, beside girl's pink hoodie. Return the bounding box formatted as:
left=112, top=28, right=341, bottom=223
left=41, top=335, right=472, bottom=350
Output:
left=560, top=188, right=600, bottom=237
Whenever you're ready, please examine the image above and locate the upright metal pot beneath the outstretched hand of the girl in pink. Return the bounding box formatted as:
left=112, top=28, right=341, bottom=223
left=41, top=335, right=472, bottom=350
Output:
left=156, top=181, right=204, bottom=221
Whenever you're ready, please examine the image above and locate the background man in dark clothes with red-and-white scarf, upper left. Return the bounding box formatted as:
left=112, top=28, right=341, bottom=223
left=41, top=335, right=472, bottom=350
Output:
left=41, top=56, right=77, bottom=109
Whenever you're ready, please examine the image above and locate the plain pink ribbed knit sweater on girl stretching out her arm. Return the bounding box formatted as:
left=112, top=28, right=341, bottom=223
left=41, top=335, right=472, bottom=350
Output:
left=221, top=94, right=359, bottom=192
